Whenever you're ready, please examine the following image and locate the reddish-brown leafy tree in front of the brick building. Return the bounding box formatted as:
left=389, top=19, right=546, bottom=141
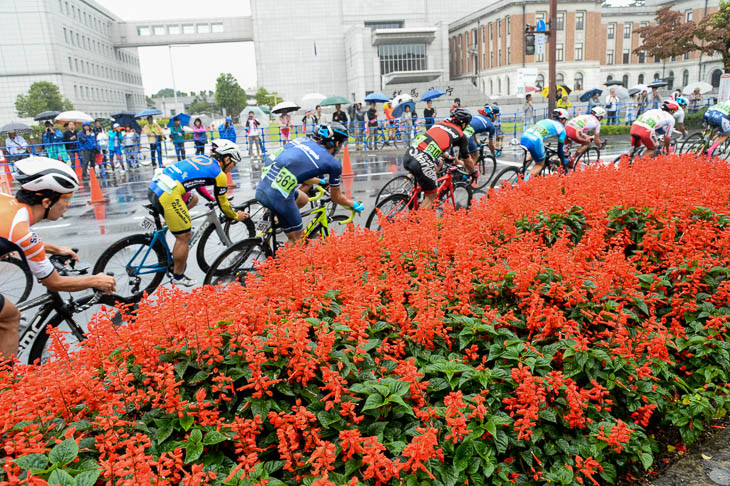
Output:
left=634, top=1, right=730, bottom=72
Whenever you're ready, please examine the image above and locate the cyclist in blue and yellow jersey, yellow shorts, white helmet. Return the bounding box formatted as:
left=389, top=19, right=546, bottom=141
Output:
left=147, top=138, right=248, bottom=287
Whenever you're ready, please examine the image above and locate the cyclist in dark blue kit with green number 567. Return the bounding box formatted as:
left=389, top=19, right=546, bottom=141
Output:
left=256, top=122, right=365, bottom=243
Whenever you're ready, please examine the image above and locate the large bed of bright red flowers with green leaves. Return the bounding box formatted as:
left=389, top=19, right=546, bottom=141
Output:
left=0, top=156, right=730, bottom=486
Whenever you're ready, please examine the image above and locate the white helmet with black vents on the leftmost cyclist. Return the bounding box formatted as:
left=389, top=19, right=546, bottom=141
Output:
left=15, top=156, right=79, bottom=194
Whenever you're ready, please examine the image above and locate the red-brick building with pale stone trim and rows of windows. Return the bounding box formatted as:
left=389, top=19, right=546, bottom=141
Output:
left=449, top=0, right=722, bottom=96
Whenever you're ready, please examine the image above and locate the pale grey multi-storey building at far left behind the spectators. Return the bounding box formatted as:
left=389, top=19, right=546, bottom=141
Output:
left=0, top=0, right=145, bottom=120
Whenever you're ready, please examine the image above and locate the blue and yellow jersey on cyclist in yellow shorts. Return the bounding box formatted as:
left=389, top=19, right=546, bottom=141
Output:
left=149, top=155, right=237, bottom=219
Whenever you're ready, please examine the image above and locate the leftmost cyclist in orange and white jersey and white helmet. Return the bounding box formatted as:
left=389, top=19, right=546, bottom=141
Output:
left=0, top=156, right=116, bottom=362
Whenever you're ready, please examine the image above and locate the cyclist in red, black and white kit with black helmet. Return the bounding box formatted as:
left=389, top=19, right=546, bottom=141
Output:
left=403, top=107, right=474, bottom=209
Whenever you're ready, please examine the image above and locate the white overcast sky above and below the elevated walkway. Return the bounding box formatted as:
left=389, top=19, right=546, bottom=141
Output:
left=96, top=0, right=256, bottom=95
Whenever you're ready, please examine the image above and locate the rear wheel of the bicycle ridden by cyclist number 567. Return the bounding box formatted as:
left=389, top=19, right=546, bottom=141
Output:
left=203, top=238, right=271, bottom=285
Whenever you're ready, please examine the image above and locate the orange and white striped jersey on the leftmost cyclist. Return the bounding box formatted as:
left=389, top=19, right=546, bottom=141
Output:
left=0, top=193, right=54, bottom=280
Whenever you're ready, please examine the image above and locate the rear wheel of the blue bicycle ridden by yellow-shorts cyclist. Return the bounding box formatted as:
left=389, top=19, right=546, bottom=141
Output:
left=93, top=233, right=172, bottom=304
